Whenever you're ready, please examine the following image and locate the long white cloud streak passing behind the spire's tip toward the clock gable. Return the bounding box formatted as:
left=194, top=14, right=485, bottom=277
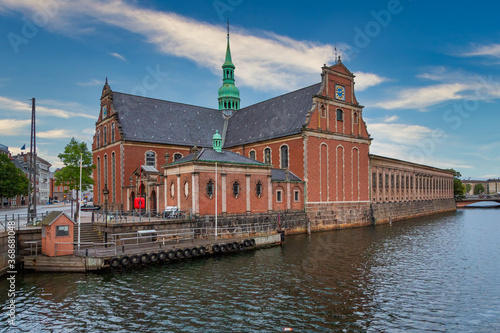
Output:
left=0, top=0, right=346, bottom=90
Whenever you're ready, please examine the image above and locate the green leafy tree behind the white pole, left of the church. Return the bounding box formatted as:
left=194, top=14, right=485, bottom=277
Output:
left=54, top=138, right=95, bottom=217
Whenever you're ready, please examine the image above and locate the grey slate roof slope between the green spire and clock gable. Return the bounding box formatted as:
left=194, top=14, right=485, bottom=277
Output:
left=224, top=83, right=321, bottom=148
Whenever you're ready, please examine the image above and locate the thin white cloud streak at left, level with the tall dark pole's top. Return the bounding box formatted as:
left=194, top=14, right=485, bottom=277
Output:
left=0, top=96, right=95, bottom=120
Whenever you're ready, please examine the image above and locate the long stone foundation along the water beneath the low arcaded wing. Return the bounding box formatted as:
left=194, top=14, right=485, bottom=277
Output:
left=371, top=199, right=457, bottom=224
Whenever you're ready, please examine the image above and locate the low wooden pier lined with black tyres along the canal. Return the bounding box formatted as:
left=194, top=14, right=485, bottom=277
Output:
left=22, top=232, right=284, bottom=272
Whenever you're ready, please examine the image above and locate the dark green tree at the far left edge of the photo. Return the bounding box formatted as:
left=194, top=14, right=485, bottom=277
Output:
left=0, top=154, right=29, bottom=198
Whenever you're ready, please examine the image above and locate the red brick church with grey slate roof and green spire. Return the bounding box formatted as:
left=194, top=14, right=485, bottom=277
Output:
left=92, top=31, right=456, bottom=228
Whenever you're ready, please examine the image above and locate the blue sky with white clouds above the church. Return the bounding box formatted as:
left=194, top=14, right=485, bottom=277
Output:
left=0, top=0, right=500, bottom=179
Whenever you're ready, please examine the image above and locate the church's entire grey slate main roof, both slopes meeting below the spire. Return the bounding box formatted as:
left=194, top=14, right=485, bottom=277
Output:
left=113, top=83, right=321, bottom=148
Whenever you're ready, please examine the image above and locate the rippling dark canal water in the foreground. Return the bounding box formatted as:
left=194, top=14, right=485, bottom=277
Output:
left=0, top=209, right=500, bottom=332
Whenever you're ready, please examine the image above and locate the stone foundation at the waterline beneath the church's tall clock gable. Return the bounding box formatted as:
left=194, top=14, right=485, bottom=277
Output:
left=306, top=202, right=373, bottom=232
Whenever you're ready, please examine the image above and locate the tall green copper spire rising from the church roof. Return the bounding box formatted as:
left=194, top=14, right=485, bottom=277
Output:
left=219, top=21, right=240, bottom=117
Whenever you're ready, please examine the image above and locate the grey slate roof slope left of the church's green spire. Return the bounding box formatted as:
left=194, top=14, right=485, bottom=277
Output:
left=113, top=92, right=224, bottom=147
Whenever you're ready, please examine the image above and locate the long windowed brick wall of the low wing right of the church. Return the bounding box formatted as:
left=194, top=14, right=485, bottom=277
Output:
left=371, top=166, right=453, bottom=203
